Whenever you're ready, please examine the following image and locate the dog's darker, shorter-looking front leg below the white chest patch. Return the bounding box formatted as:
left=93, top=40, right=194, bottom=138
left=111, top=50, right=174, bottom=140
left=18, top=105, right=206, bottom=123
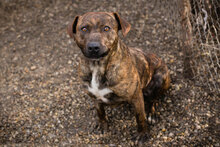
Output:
left=95, top=103, right=108, bottom=133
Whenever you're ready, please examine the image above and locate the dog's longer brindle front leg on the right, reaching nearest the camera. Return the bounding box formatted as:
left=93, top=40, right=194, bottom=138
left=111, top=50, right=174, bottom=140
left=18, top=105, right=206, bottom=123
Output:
left=133, top=92, right=149, bottom=143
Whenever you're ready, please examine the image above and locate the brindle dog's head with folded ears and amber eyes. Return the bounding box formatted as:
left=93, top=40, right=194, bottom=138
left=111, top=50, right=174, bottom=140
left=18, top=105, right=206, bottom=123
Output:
left=67, top=12, right=131, bottom=60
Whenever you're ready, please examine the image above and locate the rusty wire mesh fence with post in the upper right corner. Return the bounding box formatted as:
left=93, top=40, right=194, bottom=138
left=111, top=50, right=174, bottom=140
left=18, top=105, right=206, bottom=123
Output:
left=181, top=0, right=220, bottom=94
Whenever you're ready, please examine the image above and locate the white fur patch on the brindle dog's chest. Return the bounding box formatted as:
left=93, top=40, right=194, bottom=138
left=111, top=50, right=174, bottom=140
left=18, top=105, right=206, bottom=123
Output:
left=88, top=67, right=112, bottom=103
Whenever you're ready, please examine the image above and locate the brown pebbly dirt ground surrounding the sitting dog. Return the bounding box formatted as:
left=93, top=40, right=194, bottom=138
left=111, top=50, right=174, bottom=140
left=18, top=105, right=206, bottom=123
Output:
left=0, top=0, right=220, bottom=146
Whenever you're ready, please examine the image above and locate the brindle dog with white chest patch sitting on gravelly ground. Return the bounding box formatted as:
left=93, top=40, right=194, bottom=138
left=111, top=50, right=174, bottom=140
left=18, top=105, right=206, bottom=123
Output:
left=67, top=12, right=170, bottom=142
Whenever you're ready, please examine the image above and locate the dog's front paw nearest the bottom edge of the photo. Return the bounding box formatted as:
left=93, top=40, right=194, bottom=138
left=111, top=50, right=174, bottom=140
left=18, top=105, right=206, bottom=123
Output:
left=132, top=133, right=150, bottom=145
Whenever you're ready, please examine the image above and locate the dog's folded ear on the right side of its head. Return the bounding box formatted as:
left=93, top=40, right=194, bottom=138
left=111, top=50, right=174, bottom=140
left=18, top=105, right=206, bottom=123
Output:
left=113, top=13, right=131, bottom=37
